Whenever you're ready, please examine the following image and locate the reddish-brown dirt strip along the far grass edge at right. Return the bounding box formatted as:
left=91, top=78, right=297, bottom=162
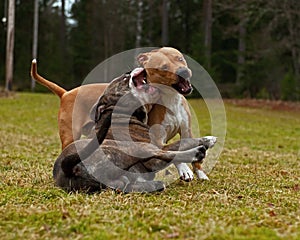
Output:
left=224, top=99, right=300, bottom=112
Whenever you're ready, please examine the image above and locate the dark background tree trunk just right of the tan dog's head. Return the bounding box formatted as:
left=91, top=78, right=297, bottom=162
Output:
left=203, top=0, right=212, bottom=68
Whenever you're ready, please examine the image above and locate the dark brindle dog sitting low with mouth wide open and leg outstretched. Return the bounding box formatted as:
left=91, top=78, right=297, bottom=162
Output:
left=53, top=68, right=216, bottom=192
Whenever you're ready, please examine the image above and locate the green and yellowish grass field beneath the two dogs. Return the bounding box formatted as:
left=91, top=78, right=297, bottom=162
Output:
left=0, top=93, right=300, bottom=239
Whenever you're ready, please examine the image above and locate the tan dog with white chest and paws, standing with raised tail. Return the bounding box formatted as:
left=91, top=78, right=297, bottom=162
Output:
left=31, top=47, right=208, bottom=180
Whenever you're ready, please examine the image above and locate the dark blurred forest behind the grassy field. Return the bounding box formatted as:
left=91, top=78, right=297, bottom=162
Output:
left=0, top=0, right=300, bottom=100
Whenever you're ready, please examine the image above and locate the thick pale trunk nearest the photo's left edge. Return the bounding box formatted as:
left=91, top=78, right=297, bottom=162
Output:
left=5, top=0, right=15, bottom=91
